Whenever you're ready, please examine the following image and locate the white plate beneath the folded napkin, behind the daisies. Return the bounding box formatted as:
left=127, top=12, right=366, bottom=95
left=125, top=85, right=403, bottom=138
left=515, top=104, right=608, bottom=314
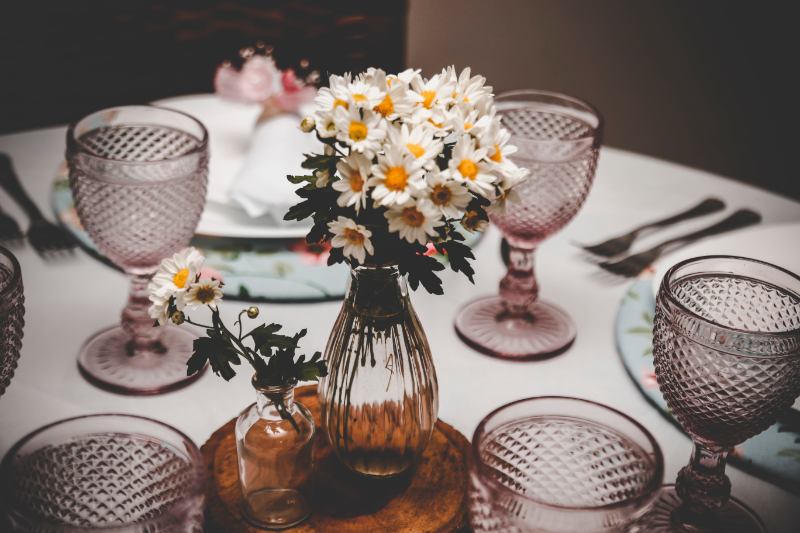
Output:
left=153, top=94, right=311, bottom=239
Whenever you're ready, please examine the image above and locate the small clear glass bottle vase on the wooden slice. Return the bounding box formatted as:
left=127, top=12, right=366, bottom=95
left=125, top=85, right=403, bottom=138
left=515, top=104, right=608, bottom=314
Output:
left=236, top=377, right=315, bottom=529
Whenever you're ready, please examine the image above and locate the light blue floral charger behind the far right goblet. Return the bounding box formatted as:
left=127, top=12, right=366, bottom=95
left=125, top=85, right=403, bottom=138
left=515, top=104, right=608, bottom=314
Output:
left=614, top=279, right=800, bottom=494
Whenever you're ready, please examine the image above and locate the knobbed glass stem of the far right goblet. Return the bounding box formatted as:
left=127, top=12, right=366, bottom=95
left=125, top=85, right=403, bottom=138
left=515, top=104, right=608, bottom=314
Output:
left=674, top=442, right=731, bottom=528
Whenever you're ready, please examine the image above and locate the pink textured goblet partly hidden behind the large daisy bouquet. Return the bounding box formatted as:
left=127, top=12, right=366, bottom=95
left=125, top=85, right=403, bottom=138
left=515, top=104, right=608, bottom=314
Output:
left=456, top=90, right=603, bottom=359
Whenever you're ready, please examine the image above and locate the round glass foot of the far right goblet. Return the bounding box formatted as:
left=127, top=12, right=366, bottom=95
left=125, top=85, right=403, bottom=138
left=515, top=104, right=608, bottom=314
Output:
left=646, top=485, right=767, bottom=533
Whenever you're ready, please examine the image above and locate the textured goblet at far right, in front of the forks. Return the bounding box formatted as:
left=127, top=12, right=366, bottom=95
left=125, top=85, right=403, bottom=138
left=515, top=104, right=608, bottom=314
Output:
left=651, top=256, right=800, bottom=533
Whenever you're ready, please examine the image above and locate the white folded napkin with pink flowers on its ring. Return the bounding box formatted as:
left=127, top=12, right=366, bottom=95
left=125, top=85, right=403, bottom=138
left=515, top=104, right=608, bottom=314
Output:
left=229, top=113, right=323, bottom=220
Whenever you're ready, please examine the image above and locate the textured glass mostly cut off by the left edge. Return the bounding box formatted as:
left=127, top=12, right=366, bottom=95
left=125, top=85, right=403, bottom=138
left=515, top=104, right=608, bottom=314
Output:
left=0, top=247, right=25, bottom=396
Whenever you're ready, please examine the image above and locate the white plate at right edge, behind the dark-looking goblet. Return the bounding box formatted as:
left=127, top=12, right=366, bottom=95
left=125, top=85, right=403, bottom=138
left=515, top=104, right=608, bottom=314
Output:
left=653, top=219, right=800, bottom=294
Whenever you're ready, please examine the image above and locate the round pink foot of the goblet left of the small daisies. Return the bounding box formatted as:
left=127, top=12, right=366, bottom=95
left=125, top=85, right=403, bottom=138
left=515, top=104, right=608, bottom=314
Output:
left=78, top=325, right=208, bottom=395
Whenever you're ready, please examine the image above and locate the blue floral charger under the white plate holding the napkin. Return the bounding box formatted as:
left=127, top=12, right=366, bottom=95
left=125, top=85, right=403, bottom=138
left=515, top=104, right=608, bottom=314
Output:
left=50, top=169, right=482, bottom=302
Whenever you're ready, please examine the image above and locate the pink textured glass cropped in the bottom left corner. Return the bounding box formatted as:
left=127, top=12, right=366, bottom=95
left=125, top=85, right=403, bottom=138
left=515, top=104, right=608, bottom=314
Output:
left=0, top=414, right=205, bottom=533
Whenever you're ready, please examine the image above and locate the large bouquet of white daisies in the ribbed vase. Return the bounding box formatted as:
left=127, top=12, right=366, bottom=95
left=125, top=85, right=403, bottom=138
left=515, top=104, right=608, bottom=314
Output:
left=285, top=67, right=527, bottom=294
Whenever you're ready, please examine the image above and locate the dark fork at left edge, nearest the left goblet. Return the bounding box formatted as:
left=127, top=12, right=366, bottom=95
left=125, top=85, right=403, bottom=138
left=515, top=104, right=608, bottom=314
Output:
left=0, top=154, right=75, bottom=253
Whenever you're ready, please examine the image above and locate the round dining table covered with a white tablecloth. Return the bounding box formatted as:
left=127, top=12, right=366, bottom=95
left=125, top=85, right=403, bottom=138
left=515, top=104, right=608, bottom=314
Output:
left=0, top=102, right=800, bottom=533
